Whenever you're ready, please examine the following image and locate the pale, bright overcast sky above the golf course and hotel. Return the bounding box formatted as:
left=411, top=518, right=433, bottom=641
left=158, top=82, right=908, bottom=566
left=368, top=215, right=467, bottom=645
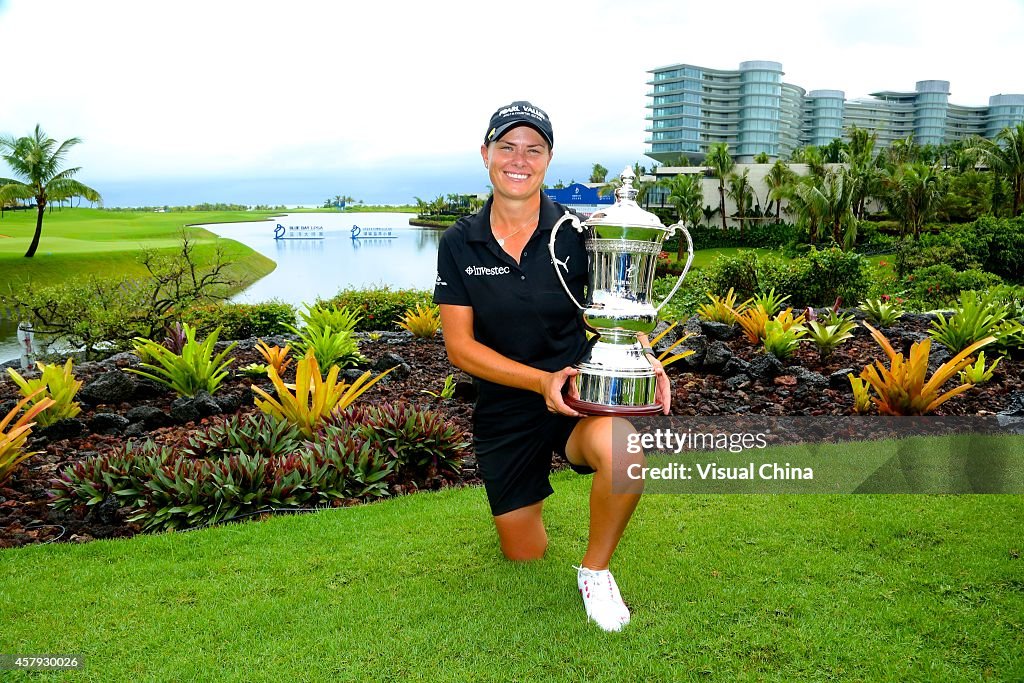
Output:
left=0, top=0, right=1024, bottom=206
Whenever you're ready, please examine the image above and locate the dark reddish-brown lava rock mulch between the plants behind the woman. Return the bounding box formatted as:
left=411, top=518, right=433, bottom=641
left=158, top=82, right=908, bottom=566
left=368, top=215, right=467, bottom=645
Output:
left=0, top=317, right=1024, bottom=548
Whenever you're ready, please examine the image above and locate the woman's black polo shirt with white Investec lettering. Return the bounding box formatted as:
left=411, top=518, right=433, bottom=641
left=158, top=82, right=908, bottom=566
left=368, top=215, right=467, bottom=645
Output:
left=434, top=193, right=588, bottom=397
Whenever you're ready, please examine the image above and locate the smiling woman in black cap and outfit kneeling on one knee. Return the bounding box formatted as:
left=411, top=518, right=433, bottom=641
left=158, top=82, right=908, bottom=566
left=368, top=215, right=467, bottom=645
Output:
left=434, top=101, right=670, bottom=631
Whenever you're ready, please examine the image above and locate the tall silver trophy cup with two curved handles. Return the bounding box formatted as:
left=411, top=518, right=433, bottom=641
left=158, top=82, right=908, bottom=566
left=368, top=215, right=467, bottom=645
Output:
left=548, top=168, right=693, bottom=416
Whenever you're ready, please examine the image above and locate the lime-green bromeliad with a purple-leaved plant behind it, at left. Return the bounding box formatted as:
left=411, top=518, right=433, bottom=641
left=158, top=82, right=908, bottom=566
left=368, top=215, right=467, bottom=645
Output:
left=128, top=324, right=237, bottom=396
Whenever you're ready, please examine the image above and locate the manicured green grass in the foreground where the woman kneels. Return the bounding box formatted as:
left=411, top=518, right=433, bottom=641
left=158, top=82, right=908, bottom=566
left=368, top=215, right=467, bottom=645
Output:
left=0, top=439, right=1024, bottom=682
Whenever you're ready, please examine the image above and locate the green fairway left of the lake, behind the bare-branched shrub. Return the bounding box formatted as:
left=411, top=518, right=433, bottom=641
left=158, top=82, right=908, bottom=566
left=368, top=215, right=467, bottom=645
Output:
left=0, top=209, right=275, bottom=291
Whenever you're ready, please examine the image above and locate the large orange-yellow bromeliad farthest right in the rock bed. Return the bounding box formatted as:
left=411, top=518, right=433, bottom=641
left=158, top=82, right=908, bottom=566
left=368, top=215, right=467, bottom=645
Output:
left=860, top=323, right=995, bottom=415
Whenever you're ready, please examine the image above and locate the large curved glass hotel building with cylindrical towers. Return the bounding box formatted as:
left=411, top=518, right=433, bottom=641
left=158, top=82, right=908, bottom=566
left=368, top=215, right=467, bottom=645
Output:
left=645, top=61, right=1024, bottom=164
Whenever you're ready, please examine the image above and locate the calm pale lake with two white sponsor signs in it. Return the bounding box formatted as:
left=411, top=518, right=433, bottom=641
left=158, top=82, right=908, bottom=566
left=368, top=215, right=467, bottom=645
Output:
left=0, top=213, right=442, bottom=361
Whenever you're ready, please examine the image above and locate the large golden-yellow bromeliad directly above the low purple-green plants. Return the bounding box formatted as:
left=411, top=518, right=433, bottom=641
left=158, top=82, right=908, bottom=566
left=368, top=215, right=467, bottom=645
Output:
left=252, top=352, right=394, bottom=438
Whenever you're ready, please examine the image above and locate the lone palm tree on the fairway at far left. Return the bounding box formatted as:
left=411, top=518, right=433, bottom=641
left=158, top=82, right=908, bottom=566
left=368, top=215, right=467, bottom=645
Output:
left=0, top=124, right=102, bottom=258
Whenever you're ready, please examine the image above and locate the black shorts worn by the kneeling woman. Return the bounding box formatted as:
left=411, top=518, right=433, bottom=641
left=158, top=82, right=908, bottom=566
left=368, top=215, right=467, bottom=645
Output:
left=473, top=393, right=594, bottom=515
